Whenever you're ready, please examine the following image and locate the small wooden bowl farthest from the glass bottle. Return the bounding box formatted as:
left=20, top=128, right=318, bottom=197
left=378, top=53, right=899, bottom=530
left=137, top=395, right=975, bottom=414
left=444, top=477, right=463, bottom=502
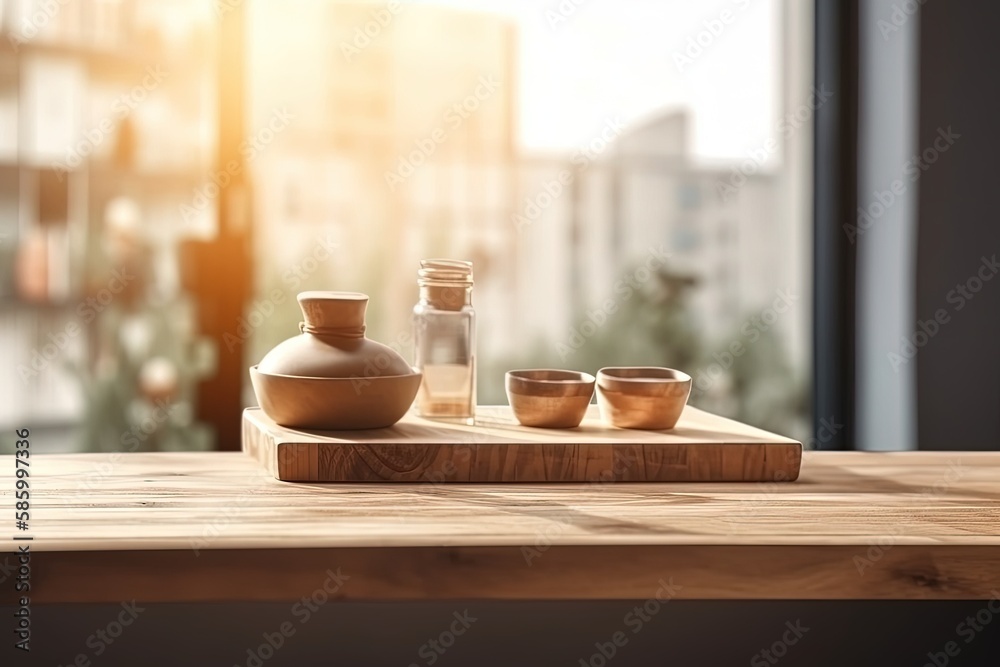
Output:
left=597, top=366, right=691, bottom=430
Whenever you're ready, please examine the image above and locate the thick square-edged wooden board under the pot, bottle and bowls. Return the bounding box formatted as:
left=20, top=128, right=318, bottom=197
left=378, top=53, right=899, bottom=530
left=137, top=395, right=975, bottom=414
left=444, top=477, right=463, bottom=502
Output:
left=242, top=405, right=802, bottom=483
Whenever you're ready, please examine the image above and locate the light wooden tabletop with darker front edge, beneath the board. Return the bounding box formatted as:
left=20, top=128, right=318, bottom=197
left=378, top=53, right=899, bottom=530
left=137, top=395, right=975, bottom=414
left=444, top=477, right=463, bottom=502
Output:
left=0, top=452, right=1000, bottom=603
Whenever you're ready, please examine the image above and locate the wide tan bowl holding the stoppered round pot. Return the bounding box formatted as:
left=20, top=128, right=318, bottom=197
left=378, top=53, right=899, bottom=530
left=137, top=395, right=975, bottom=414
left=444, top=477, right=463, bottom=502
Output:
left=250, top=366, right=423, bottom=430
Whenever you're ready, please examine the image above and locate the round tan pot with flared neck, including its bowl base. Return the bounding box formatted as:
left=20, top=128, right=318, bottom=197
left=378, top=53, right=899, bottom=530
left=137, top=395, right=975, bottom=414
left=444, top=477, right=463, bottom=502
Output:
left=250, top=292, right=421, bottom=430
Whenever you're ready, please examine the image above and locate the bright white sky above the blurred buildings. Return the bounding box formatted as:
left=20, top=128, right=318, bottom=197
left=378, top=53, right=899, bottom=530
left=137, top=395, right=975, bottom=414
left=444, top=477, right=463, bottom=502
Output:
left=418, top=0, right=781, bottom=160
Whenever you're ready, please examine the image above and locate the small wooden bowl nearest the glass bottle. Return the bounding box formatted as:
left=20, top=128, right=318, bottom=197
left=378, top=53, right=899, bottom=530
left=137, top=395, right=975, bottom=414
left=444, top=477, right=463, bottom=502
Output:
left=504, top=368, right=595, bottom=428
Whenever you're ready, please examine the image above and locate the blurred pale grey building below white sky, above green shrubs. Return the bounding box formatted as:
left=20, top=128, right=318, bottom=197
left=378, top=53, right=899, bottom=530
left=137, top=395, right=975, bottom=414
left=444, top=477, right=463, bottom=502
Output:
left=514, top=112, right=792, bottom=360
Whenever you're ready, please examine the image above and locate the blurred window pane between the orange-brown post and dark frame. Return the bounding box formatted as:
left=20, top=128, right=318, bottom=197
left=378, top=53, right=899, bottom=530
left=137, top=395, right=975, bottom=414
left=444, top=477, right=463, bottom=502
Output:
left=248, top=0, right=812, bottom=436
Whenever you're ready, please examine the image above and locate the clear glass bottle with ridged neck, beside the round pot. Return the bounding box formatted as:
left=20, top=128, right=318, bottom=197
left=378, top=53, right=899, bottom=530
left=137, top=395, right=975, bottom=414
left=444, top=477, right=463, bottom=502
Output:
left=413, top=259, right=476, bottom=424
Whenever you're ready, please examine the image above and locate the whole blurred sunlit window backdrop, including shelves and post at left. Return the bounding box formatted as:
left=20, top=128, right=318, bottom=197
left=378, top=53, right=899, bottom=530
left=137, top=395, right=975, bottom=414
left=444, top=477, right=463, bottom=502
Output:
left=0, top=0, right=812, bottom=450
